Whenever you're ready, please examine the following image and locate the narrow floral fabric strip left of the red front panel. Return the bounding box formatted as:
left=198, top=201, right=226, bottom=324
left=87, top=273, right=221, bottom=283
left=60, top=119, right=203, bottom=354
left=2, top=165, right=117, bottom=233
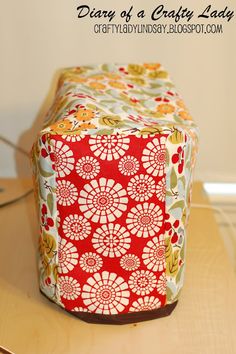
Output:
left=34, top=134, right=60, bottom=304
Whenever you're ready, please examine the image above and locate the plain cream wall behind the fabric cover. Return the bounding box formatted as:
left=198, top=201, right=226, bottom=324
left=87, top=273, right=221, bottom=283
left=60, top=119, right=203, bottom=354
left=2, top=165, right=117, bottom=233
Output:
left=0, top=0, right=236, bottom=181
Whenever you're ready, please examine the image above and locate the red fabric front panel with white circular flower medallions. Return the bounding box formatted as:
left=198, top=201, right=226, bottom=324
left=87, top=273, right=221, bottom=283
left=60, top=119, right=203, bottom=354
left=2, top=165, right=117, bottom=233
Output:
left=53, top=135, right=166, bottom=314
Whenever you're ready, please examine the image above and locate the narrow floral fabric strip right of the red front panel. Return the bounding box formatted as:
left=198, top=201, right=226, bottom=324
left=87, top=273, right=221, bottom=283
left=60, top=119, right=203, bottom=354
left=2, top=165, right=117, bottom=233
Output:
left=165, top=130, right=192, bottom=304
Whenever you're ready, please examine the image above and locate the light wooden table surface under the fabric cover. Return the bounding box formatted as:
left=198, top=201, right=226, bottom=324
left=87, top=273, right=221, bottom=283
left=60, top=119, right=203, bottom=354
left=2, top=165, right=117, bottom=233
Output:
left=0, top=180, right=236, bottom=354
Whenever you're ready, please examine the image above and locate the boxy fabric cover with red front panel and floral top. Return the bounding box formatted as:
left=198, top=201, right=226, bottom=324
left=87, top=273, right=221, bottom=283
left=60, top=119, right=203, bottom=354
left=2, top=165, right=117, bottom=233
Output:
left=32, top=63, right=198, bottom=317
